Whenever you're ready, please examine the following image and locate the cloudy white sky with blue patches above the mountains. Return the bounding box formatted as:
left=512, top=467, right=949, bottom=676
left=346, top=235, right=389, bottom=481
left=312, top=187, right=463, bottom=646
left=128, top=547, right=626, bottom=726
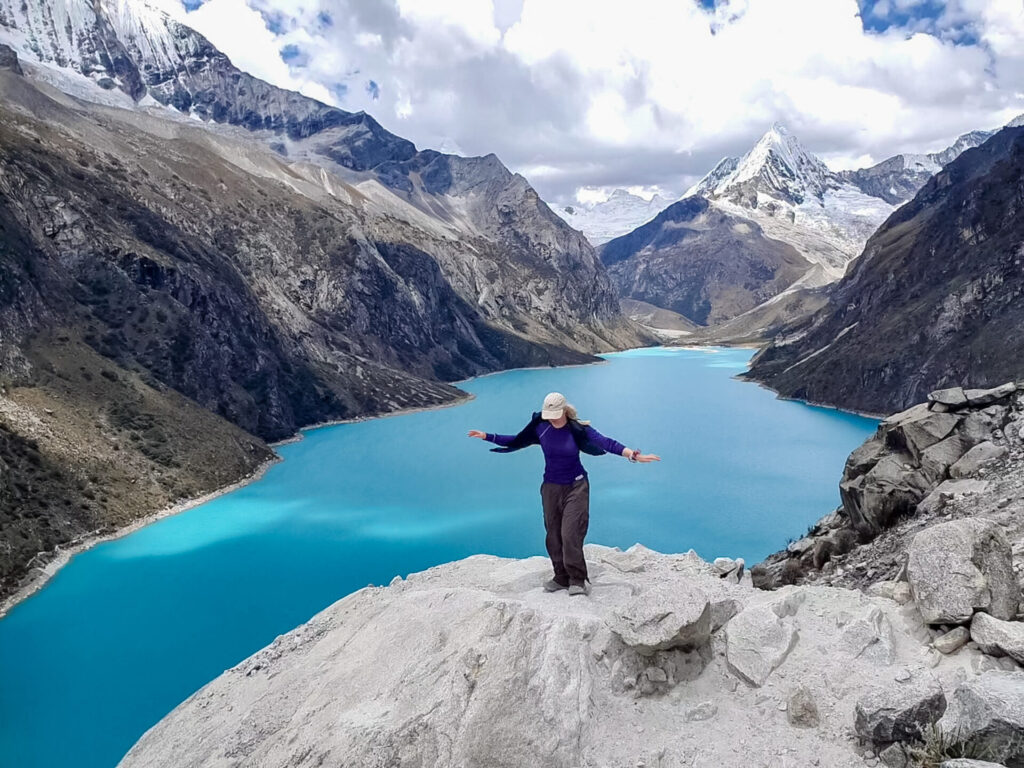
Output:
left=160, top=0, right=1024, bottom=202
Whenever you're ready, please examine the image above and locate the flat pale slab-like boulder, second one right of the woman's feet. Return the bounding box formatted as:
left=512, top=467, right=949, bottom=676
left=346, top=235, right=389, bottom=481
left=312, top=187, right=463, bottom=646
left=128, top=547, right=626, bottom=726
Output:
left=725, top=593, right=800, bottom=686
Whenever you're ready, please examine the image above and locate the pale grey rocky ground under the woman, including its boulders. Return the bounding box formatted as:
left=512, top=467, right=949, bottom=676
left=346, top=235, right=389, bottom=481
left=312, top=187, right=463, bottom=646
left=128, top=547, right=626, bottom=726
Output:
left=121, top=545, right=1024, bottom=768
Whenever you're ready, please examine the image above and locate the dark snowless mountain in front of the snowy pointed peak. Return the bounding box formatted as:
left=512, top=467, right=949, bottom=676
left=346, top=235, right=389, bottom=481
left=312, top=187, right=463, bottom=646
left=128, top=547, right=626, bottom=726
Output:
left=600, top=198, right=811, bottom=325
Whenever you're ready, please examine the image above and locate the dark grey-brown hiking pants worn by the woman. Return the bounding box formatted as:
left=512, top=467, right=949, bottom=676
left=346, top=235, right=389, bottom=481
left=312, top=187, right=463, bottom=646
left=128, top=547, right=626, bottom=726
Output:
left=541, top=477, right=590, bottom=586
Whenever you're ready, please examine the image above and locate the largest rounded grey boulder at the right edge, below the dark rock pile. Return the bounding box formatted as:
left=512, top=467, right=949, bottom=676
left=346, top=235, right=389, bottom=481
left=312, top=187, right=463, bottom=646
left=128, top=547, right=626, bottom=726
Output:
left=907, top=518, right=1020, bottom=624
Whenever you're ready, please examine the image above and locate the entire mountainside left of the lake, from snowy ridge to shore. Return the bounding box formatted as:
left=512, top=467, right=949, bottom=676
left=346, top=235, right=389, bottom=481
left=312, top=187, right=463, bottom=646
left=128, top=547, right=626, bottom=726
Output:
left=0, top=0, right=650, bottom=592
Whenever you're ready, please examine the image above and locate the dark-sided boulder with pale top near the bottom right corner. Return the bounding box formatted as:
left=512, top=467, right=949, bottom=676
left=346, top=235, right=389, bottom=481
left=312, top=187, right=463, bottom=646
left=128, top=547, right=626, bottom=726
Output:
left=854, top=676, right=946, bottom=748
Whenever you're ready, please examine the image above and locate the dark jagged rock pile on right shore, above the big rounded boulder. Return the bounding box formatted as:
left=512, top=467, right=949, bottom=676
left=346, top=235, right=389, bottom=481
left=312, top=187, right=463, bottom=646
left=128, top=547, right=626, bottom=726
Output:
left=753, top=382, right=1024, bottom=594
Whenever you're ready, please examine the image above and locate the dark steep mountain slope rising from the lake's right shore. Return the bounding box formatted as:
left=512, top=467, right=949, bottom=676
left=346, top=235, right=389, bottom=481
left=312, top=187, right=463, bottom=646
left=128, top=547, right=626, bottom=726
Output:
left=749, top=128, right=1024, bottom=413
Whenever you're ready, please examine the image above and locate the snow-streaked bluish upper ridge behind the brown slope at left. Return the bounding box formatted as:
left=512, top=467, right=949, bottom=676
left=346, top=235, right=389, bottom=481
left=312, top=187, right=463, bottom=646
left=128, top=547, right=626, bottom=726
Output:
left=0, top=0, right=638, bottom=351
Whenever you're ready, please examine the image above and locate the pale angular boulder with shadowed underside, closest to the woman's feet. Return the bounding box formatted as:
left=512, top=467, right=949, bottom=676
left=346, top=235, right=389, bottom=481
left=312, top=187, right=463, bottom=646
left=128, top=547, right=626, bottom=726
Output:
left=608, top=583, right=713, bottom=654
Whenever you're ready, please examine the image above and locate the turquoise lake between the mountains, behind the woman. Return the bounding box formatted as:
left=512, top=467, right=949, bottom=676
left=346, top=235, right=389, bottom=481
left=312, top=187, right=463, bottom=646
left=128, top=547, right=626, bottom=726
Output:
left=0, top=349, right=876, bottom=768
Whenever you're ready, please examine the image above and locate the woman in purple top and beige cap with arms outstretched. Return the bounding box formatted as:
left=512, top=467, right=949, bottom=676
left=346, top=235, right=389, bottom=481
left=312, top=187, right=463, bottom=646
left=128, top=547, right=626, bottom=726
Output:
left=469, top=392, right=662, bottom=595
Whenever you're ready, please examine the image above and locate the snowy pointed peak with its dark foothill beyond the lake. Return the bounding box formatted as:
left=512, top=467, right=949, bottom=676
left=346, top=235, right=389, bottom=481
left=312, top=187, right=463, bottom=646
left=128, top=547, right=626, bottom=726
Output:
left=599, top=123, right=1015, bottom=333
